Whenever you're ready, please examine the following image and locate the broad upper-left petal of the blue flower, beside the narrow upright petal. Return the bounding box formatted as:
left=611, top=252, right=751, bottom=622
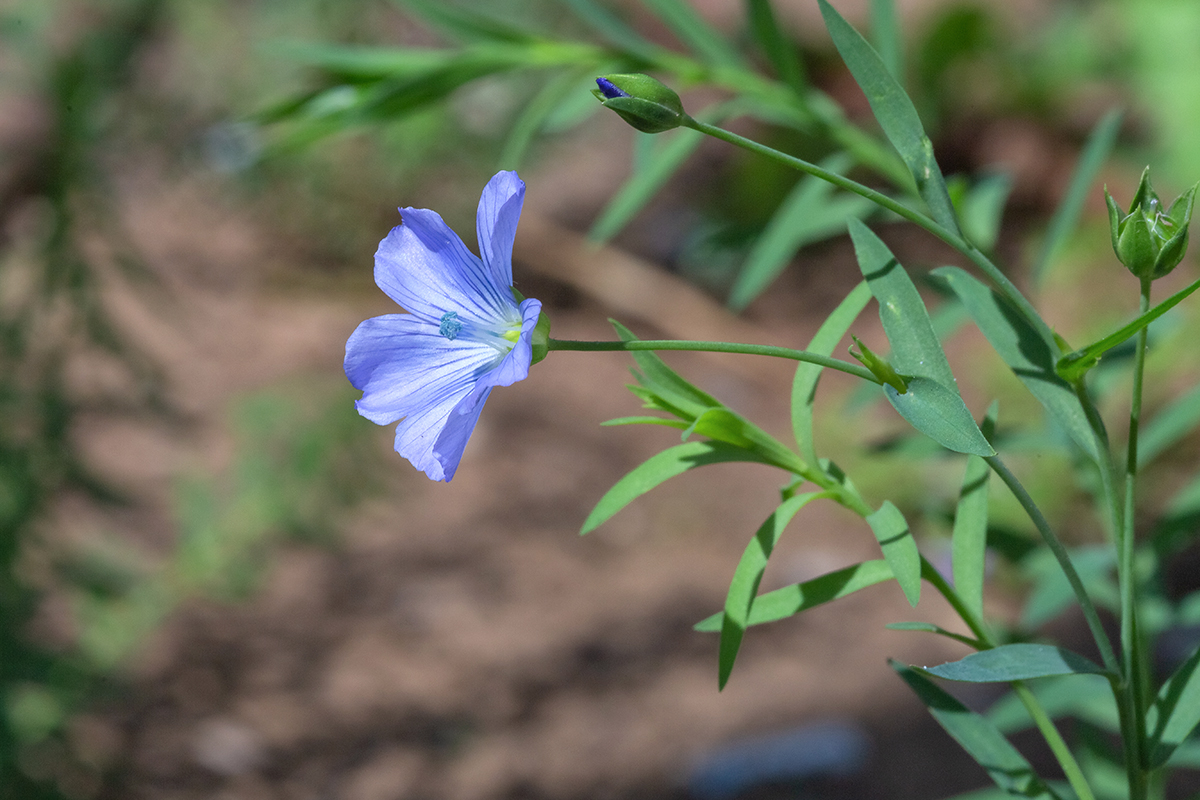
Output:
left=374, top=209, right=516, bottom=325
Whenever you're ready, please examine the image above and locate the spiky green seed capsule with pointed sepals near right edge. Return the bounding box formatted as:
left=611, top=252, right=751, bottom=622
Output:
left=1104, top=167, right=1200, bottom=281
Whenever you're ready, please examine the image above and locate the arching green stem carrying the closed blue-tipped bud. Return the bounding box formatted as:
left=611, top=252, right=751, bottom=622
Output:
left=683, top=115, right=1057, bottom=350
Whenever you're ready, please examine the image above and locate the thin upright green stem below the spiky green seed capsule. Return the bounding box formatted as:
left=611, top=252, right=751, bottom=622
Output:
left=1117, top=278, right=1151, bottom=800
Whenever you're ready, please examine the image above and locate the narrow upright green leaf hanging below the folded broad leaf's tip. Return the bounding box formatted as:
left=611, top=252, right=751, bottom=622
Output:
left=950, top=402, right=998, bottom=620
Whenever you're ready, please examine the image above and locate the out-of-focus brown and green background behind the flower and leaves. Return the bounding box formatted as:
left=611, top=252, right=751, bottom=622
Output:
left=0, top=0, right=1200, bottom=800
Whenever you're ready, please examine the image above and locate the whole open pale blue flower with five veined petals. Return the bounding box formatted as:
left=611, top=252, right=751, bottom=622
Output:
left=344, top=172, right=541, bottom=481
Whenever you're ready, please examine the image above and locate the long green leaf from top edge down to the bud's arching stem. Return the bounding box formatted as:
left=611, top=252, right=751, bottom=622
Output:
left=817, top=0, right=960, bottom=233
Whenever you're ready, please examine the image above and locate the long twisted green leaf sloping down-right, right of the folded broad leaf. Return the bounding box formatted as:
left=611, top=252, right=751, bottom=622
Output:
left=932, top=266, right=1099, bottom=462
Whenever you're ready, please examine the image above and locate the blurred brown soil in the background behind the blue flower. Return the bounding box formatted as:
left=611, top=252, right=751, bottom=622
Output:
left=23, top=128, right=1027, bottom=800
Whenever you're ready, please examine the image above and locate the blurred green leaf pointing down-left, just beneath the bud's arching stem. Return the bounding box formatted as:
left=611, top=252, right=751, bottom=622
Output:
left=728, top=154, right=875, bottom=311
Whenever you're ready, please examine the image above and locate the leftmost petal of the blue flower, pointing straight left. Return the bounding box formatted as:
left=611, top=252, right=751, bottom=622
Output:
left=344, top=314, right=497, bottom=424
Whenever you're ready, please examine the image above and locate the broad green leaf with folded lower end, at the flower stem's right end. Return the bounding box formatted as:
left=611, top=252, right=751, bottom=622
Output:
left=848, top=219, right=996, bottom=456
